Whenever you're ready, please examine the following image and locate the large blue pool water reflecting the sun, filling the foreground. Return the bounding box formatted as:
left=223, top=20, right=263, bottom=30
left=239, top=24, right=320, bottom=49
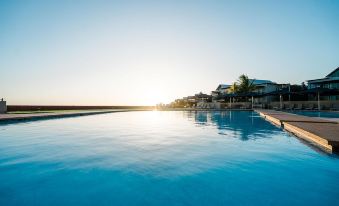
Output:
left=0, top=112, right=339, bottom=206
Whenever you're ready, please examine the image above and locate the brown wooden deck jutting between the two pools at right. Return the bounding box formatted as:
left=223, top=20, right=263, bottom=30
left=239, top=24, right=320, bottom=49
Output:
left=256, top=110, right=339, bottom=152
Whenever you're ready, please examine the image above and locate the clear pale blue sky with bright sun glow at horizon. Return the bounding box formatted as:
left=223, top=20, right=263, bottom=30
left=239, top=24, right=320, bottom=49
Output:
left=0, top=0, right=339, bottom=105
